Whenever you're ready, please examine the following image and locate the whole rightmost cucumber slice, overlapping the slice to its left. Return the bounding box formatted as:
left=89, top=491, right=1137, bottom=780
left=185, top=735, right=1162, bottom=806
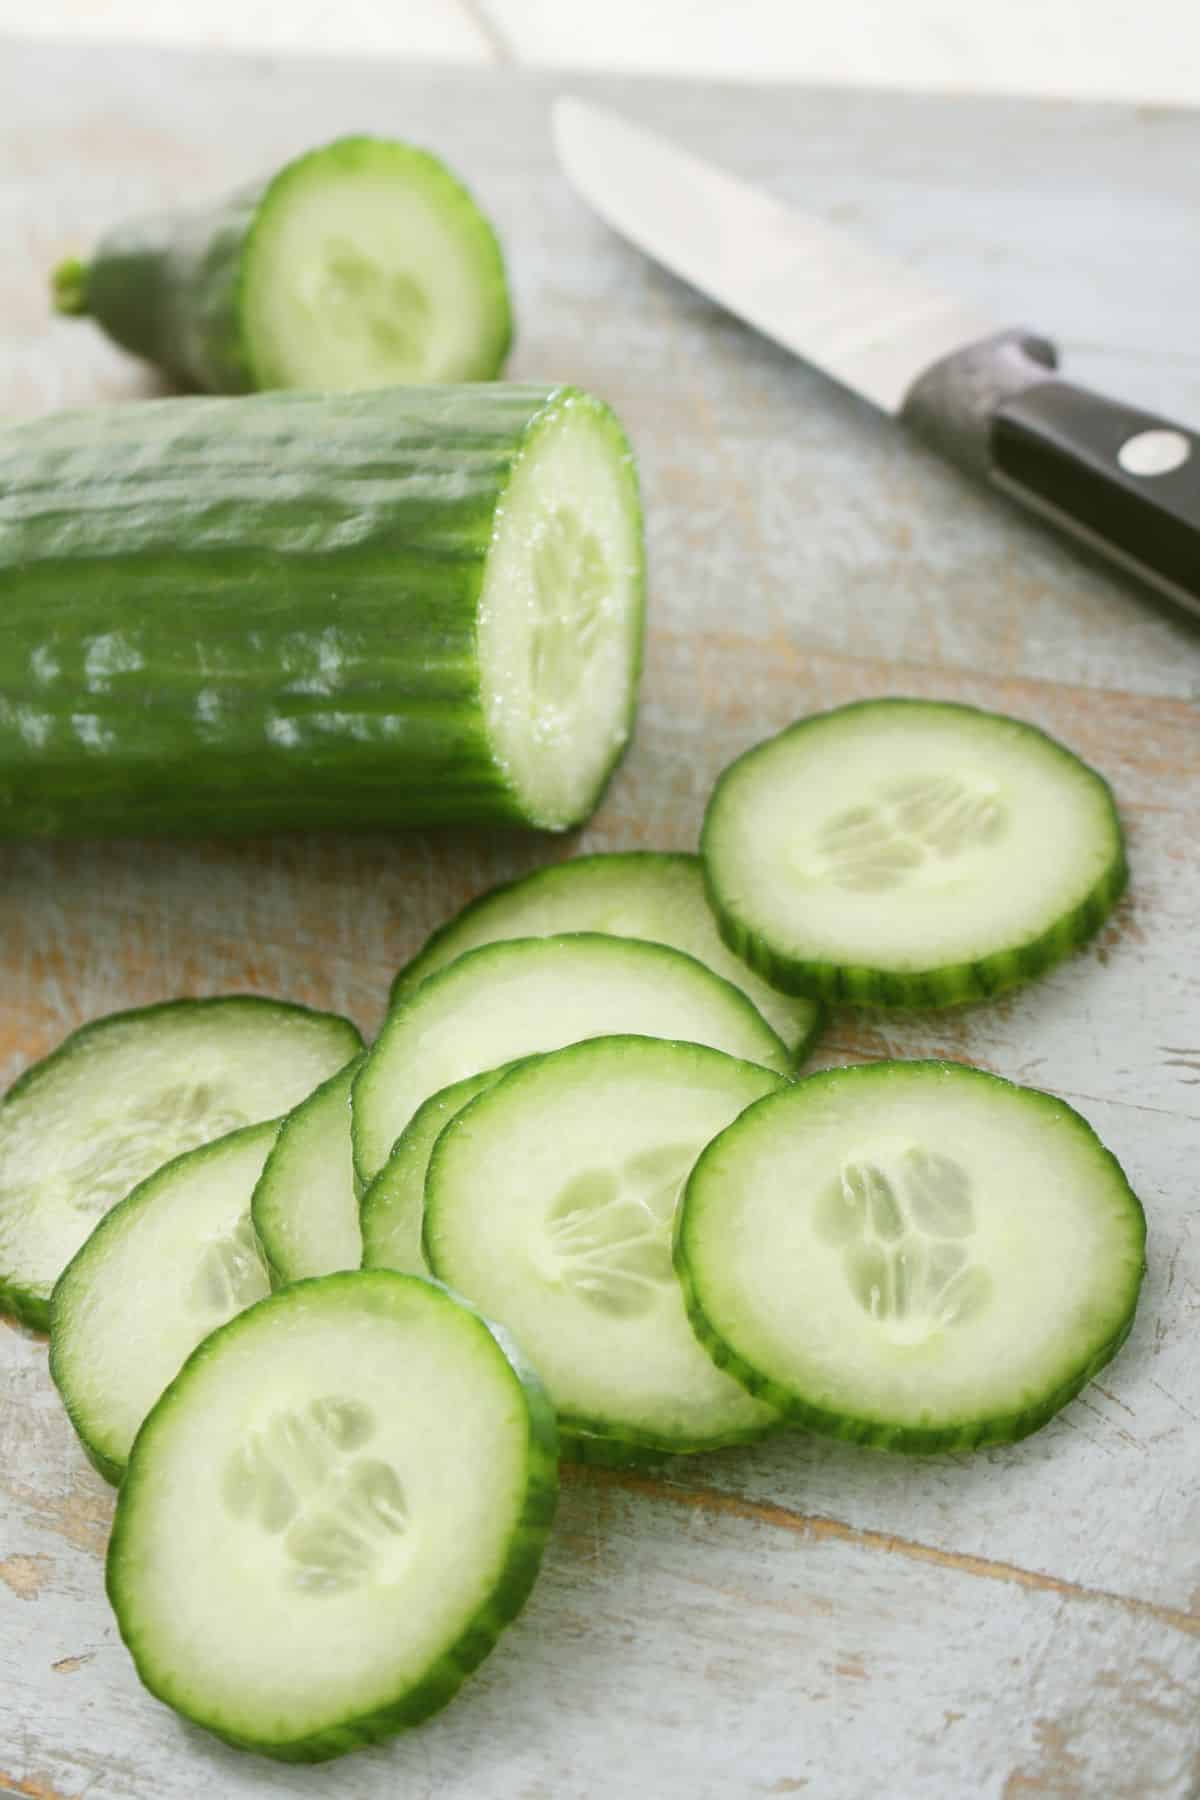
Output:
left=675, top=1062, right=1146, bottom=1451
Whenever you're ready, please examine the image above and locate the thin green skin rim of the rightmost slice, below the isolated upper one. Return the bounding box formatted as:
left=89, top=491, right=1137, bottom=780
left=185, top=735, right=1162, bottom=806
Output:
left=673, top=1058, right=1146, bottom=1456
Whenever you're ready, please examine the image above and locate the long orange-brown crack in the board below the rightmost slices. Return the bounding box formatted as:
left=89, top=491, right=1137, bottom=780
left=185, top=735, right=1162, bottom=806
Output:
left=563, top=1465, right=1200, bottom=1638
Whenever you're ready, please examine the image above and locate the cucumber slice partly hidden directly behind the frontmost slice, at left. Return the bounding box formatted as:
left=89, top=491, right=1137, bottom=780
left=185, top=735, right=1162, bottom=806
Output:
left=50, top=1120, right=279, bottom=1481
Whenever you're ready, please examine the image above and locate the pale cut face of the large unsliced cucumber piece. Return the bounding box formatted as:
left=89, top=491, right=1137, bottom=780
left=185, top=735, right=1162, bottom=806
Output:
left=479, top=389, right=644, bottom=830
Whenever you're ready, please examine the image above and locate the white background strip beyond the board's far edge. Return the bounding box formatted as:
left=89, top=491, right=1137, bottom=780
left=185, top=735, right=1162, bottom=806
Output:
left=0, top=0, right=1200, bottom=104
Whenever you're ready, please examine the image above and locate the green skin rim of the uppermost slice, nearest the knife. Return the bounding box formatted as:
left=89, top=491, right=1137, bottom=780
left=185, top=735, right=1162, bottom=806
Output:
left=700, top=697, right=1130, bottom=1012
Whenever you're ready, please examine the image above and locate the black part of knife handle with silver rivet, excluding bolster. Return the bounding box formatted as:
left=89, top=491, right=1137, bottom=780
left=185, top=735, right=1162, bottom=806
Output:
left=991, top=382, right=1200, bottom=612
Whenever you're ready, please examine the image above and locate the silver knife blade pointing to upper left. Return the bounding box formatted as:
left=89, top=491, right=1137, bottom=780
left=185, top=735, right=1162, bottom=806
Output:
left=554, top=99, right=997, bottom=412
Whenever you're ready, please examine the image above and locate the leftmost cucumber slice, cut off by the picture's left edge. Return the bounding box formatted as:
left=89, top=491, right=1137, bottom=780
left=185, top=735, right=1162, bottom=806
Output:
left=0, top=994, right=362, bottom=1330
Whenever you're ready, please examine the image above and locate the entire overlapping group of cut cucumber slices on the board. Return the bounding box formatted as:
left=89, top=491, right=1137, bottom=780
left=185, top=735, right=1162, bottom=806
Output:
left=0, top=702, right=1146, bottom=1760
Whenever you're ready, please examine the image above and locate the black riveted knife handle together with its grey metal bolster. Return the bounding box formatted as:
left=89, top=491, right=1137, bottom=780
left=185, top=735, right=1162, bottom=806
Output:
left=901, top=331, right=1200, bottom=614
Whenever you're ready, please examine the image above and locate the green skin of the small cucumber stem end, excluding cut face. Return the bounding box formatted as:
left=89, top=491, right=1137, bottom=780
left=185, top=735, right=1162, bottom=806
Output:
left=54, top=137, right=513, bottom=394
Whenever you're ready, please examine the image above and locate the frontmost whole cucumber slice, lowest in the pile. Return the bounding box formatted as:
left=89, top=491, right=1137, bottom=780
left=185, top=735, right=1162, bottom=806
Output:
left=108, top=1269, right=558, bottom=1762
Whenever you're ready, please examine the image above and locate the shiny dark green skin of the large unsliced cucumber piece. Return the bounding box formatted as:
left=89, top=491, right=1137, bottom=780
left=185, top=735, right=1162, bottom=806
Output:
left=0, top=383, right=628, bottom=841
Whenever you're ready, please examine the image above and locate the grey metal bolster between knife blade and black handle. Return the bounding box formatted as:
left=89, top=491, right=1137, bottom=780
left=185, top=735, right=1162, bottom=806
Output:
left=900, top=331, right=1058, bottom=475
